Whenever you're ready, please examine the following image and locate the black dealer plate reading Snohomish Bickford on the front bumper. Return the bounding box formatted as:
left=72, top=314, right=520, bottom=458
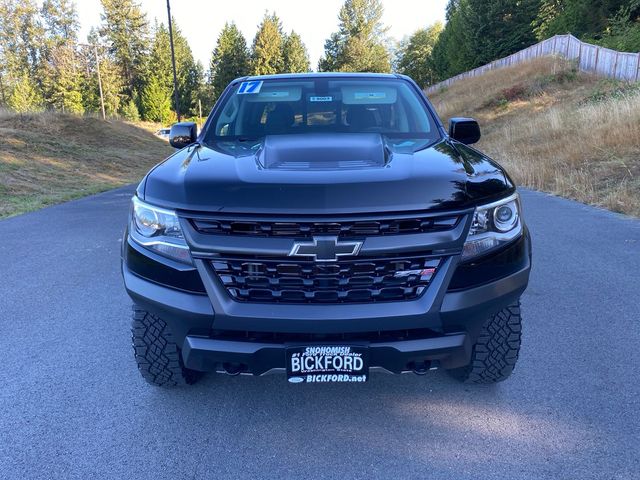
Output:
left=286, top=345, right=369, bottom=383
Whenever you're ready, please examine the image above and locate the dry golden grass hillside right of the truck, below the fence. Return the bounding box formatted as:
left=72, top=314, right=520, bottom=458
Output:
left=430, top=58, right=640, bottom=216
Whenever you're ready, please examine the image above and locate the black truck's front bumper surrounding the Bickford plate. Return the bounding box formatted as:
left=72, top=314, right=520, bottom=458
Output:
left=122, top=230, right=531, bottom=375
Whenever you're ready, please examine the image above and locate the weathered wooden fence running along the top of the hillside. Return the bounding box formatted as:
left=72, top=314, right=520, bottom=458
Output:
left=425, top=35, right=640, bottom=93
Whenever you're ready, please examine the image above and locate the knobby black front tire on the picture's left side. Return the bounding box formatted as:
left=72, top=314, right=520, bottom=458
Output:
left=131, top=305, right=200, bottom=387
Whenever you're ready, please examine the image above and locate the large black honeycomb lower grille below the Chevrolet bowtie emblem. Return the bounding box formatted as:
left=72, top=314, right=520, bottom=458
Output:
left=211, top=256, right=441, bottom=303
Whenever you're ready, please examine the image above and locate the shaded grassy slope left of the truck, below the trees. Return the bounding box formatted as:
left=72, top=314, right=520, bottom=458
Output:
left=0, top=112, right=172, bottom=217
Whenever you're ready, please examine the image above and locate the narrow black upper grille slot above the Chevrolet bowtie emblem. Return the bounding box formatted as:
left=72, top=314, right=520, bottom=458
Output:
left=191, top=215, right=460, bottom=238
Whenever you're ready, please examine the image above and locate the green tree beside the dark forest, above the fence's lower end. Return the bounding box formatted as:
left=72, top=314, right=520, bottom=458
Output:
left=397, top=22, right=444, bottom=87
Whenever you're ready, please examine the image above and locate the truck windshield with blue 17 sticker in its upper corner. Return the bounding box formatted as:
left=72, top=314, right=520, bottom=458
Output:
left=205, top=77, right=440, bottom=147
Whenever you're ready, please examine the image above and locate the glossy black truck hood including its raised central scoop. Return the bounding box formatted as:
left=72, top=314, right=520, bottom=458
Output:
left=144, top=134, right=514, bottom=214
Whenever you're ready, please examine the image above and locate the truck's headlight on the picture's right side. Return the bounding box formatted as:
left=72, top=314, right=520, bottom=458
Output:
left=462, top=193, right=522, bottom=261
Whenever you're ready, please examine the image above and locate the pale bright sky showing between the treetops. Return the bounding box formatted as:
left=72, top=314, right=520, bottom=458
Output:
left=75, top=0, right=447, bottom=69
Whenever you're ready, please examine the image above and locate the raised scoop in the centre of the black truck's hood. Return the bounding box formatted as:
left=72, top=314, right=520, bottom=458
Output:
left=256, top=133, right=391, bottom=171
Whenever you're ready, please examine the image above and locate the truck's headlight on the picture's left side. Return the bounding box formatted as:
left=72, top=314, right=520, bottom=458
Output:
left=129, top=197, right=192, bottom=264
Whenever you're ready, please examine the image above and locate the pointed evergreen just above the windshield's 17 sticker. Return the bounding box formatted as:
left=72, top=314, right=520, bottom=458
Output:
left=209, top=22, right=251, bottom=100
